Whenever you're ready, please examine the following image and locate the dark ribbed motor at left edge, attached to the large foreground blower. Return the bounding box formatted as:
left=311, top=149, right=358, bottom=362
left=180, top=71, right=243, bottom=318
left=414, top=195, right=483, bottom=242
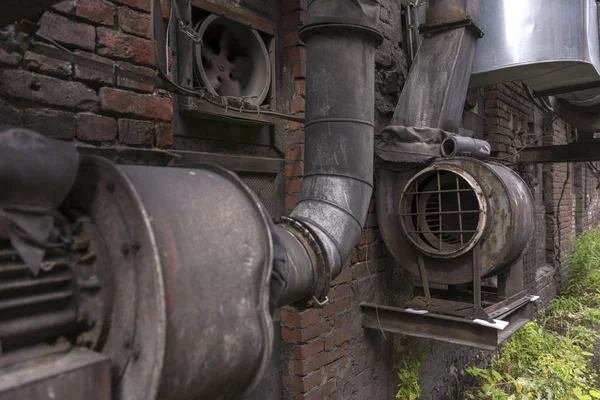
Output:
left=0, top=212, right=111, bottom=352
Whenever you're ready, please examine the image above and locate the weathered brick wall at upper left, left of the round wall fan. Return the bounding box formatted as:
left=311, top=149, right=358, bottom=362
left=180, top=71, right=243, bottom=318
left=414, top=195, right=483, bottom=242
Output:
left=0, top=0, right=173, bottom=148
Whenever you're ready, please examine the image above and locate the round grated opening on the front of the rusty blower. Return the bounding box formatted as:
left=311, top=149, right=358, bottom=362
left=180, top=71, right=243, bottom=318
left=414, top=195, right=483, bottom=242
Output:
left=400, top=166, right=487, bottom=258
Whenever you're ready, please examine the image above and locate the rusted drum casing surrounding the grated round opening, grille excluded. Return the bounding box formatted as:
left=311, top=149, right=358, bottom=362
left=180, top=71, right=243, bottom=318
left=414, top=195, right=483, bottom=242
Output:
left=377, top=158, right=534, bottom=285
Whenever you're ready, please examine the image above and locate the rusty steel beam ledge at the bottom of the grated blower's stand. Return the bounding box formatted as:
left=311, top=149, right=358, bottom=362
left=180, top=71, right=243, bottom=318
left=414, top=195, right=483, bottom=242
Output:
left=361, top=296, right=533, bottom=351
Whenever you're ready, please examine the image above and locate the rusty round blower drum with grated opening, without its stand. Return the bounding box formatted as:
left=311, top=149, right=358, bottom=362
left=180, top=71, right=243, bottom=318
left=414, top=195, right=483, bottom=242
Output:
left=378, top=157, right=534, bottom=284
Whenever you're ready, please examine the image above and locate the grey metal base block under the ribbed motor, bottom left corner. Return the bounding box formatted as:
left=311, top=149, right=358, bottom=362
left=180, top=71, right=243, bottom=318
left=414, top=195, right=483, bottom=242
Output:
left=0, top=348, right=113, bottom=400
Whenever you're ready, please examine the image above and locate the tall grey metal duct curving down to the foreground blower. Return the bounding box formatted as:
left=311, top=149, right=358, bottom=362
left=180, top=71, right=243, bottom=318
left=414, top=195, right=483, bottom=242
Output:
left=279, top=0, right=382, bottom=304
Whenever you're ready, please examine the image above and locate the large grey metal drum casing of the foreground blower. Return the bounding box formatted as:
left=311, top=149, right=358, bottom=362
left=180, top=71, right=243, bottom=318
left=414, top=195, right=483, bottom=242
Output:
left=69, top=157, right=273, bottom=400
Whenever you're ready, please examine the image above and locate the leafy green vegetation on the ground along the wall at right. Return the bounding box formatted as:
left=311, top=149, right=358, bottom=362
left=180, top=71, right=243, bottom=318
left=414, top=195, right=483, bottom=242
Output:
left=464, top=229, right=600, bottom=400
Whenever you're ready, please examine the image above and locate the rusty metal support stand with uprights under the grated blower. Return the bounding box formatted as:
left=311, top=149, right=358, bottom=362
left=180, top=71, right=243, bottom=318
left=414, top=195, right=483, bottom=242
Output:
left=361, top=255, right=534, bottom=350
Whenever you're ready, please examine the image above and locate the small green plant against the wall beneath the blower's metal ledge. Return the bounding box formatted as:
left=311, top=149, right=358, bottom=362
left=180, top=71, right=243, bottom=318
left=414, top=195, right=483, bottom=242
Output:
left=396, top=339, right=427, bottom=400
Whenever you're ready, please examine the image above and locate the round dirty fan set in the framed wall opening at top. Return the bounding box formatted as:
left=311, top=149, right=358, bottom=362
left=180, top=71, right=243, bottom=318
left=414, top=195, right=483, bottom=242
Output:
left=194, top=15, right=271, bottom=106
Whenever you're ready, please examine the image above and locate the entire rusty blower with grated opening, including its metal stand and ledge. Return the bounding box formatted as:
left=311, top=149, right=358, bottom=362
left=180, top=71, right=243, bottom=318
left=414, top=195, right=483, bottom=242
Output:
left=362, top=157, right=535, bottom=350
